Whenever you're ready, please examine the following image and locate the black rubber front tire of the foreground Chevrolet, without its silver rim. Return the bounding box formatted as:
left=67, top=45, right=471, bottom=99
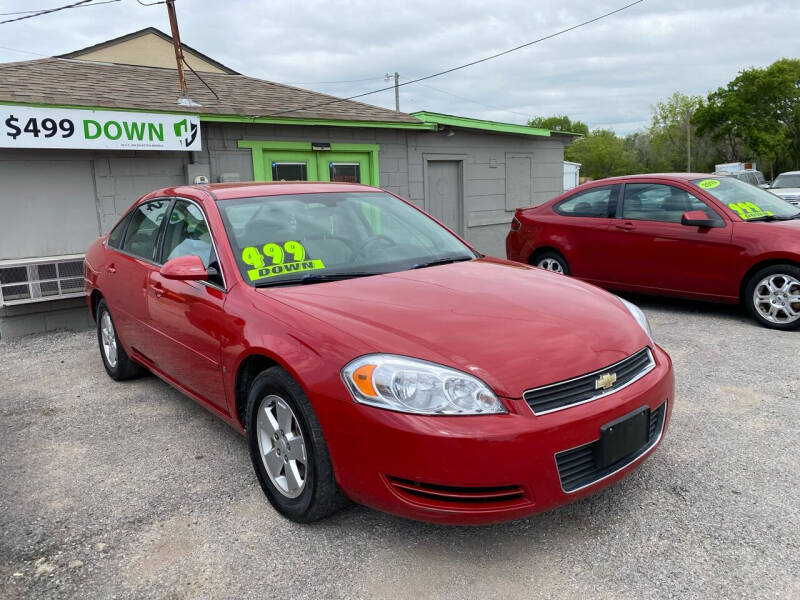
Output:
left=245, top=367, right=348, bottom=523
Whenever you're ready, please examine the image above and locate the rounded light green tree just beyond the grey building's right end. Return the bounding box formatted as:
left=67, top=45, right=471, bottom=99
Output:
left=564, top=129, right=640, bottom=179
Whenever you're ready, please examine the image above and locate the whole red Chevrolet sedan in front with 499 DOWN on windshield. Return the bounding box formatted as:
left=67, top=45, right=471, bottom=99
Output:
left=85, top=183, right=674, bottom=523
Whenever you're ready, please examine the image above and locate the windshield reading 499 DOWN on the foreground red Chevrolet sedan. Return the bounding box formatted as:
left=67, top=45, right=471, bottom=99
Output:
left=218, top=191, right=476, bottom=287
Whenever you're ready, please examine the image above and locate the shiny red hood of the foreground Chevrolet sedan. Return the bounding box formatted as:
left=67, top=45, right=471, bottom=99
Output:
left=258, top=258, right=650, bottom=398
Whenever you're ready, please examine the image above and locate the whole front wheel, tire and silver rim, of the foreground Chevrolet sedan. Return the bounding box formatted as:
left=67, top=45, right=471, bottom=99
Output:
left=245, top=367, right=347, bottom=523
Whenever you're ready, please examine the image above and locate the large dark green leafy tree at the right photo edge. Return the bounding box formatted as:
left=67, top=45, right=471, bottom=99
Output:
left=693, top=58, right=800, bottom=172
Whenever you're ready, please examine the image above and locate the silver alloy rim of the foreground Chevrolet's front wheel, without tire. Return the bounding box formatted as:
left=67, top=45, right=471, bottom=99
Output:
left=256, top=395, right=308, bottom=498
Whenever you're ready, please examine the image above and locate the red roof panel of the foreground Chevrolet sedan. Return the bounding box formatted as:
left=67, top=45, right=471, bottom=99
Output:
left=142, top=181, right=381, bottom=200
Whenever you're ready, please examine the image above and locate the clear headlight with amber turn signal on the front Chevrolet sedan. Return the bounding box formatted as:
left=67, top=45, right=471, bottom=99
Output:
left=342, top=354, right=506, bottom=415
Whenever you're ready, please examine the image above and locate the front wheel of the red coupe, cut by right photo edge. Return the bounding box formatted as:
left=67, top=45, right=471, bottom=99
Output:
left=744, top=265, right=800, bottom=330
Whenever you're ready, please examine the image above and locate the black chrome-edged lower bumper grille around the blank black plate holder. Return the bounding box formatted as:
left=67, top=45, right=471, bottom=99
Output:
left=556, top=402, right=667, bottom=492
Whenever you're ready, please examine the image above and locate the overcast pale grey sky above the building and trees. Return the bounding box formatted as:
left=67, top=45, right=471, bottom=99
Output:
left=0, top=0, right=800, bottom=134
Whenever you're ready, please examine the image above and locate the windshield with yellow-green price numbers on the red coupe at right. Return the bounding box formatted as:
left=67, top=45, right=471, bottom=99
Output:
left=692, top=177, right=800, bottom=221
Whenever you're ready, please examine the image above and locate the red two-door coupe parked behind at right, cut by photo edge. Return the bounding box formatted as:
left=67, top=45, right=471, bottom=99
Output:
left=506, top=173, right=800, bottom=329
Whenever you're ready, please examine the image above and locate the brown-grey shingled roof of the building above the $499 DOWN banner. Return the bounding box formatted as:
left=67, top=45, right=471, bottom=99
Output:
left=0, top=58, right=421, bottom=124
